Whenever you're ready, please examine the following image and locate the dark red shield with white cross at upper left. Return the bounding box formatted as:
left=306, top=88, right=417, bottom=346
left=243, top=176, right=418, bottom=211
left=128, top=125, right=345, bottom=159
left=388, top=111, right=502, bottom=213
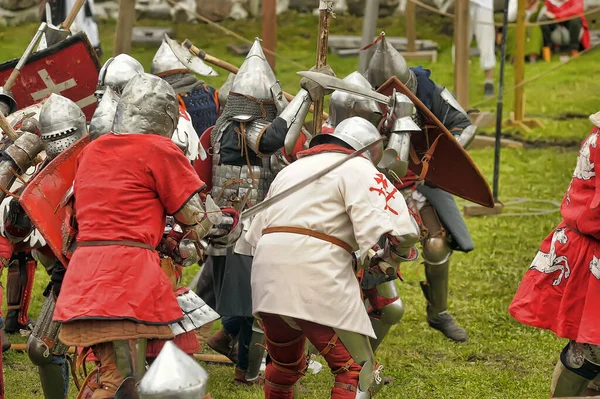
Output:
left=0, top=33, right=100, bottom=121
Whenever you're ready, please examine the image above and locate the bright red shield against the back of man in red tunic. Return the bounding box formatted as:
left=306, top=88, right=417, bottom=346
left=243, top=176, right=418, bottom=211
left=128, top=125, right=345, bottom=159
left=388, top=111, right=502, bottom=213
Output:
left=19, top=136, right=90, bottom=266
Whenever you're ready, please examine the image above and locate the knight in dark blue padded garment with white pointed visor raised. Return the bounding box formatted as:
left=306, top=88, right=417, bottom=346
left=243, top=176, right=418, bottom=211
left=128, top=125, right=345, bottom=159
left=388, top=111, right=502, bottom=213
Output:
left=152, top=40, right=219, bottom=135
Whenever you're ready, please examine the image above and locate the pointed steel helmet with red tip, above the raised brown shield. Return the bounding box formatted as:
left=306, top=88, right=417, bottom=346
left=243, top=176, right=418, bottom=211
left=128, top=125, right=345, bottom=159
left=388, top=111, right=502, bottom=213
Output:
left=366, top=32, right=417, bottom=93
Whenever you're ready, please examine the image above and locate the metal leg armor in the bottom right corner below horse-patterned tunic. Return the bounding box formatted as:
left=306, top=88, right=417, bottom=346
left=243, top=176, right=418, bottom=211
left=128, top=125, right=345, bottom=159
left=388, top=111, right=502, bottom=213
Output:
left=550, top=341, right=600, bottom=398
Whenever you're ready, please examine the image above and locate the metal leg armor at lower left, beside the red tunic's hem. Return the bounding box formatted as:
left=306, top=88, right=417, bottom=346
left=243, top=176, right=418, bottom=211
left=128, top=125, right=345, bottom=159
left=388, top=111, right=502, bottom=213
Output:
left=27, top=292, right=69, bottom=399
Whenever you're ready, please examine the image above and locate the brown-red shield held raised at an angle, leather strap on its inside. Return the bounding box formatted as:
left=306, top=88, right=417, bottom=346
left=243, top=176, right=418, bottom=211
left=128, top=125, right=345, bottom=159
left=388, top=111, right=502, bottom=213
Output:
left=377, top=76, right=494, bottom=208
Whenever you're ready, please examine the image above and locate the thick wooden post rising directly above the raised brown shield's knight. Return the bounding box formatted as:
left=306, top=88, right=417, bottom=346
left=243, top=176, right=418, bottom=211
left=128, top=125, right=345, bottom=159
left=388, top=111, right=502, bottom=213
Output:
left=454, top=0, right=471, bottom=108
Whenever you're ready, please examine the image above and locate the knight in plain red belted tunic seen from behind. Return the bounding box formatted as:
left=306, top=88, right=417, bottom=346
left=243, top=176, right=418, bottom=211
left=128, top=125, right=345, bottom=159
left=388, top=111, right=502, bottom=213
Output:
left=53, top=74, right=239, bottom=398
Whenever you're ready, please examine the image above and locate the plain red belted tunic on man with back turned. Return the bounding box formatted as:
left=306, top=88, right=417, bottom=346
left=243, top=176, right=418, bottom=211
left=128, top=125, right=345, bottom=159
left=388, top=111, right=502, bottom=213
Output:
left=54, top=134, right=204, bottom=324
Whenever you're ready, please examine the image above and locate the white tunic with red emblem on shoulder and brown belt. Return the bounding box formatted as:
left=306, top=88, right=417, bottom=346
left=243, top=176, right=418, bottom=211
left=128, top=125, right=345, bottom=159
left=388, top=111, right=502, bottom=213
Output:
left=246, top=152, right=417, bottom=337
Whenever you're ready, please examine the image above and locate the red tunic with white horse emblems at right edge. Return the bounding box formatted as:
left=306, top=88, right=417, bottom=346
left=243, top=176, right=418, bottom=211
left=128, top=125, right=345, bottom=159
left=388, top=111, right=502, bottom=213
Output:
left=509, top=128, right=600, bottom=345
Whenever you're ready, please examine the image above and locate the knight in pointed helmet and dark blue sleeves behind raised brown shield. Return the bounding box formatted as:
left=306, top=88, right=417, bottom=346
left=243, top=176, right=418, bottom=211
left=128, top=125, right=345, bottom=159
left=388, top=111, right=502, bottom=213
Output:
left=366, top=33, right=477, bottom=342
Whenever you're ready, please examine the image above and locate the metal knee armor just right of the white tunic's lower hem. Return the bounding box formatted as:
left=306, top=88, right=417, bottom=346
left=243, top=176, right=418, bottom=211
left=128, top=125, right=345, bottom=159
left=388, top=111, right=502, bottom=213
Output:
left=369, top=280, right=404, bottom=352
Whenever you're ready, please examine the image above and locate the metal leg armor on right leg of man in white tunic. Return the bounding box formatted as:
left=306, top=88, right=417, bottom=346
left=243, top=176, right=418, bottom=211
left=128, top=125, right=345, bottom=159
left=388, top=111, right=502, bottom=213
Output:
left=334, top=328, right=383, bottom=399
